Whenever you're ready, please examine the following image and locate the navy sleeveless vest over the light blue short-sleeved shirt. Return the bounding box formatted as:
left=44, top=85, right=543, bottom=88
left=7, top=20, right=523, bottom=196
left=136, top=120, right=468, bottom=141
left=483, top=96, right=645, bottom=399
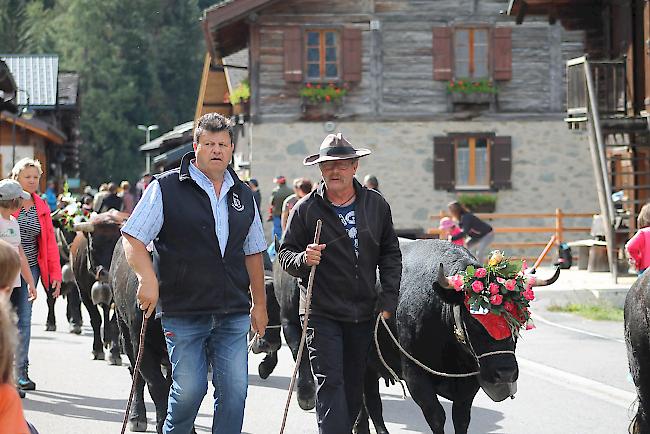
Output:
left=154, top=152, right=255, bottom=315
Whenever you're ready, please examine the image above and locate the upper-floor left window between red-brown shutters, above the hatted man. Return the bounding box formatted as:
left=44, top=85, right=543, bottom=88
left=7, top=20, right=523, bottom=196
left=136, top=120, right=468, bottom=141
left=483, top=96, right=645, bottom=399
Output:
left=305, top=30, right=341, bottom=81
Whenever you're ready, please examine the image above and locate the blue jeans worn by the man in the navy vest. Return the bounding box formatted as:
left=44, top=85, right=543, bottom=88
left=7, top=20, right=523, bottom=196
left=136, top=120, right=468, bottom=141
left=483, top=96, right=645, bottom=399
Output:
left=162, top=313, right=250, bottom=434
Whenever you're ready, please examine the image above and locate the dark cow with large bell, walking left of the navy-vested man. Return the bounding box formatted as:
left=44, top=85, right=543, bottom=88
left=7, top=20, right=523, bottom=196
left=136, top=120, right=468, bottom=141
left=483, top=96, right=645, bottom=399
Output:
left=71, top=211, right=127, bottom=365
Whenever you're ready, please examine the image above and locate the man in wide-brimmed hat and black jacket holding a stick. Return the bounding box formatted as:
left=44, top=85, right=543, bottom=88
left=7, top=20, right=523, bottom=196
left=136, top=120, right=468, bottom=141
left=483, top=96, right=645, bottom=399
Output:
left=279, top=133, right=402, bottom=434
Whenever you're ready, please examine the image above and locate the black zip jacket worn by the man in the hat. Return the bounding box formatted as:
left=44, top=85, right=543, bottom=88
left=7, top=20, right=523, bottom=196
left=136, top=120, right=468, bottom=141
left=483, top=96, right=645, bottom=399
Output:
left=278, top=180, right=402, bottom=322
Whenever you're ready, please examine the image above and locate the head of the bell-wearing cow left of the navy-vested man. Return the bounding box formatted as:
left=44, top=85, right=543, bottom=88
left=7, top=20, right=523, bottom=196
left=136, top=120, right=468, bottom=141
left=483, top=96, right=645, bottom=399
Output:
left=74, top=211, right=128, bottom=291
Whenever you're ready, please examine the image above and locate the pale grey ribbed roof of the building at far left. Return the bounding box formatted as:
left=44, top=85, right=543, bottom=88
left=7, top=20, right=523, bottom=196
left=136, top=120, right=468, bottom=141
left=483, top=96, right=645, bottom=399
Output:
left=0, top=54, right=59, bottom=108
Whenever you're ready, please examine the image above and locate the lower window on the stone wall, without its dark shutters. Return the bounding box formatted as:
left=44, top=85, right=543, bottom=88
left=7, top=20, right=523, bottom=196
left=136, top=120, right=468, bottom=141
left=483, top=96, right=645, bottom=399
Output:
left=454, top=137, right=490, bottom=188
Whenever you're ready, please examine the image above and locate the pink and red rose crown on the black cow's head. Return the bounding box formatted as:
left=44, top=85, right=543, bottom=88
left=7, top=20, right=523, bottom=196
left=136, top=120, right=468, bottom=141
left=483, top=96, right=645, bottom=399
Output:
left=449, top=250, right=535, bottom=338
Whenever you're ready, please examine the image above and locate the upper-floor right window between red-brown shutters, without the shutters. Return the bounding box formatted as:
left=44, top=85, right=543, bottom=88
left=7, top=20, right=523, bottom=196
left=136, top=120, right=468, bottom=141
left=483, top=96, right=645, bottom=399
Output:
left=454, top=28, right=490, bottom=78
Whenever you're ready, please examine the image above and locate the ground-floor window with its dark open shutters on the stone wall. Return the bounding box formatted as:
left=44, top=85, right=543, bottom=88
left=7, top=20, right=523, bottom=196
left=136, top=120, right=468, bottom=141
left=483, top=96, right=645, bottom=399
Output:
left=433, top=132, right=512, bottom=191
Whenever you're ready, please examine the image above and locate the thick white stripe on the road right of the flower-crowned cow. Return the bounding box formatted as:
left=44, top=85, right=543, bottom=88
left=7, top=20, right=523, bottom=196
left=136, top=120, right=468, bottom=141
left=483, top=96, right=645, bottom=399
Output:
left=517, top=357, right=636, bottom=409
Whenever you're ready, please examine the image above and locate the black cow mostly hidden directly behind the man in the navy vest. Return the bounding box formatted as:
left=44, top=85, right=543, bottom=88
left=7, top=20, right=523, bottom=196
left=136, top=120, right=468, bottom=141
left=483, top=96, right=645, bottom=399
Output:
left=109, top=238, right=177, bottom=433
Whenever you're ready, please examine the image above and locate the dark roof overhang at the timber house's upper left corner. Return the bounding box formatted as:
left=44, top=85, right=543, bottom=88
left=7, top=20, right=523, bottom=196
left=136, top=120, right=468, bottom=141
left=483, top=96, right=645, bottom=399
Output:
left=201, top=0, right=278, bottom=59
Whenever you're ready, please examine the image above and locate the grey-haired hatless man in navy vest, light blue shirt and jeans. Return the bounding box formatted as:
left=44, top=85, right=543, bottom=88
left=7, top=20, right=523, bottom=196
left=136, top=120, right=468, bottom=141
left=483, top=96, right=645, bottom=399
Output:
left=122, top=113, right=268, bottom=434
